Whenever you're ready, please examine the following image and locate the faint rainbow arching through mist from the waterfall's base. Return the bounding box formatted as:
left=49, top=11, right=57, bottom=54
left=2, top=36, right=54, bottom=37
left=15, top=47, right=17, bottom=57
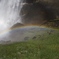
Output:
left=0, top=25, right=58, bottom=36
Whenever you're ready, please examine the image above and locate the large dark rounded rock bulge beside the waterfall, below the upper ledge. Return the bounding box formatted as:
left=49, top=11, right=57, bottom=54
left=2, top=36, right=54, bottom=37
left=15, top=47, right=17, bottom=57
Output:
left=21, top=3, right=56, bottom=24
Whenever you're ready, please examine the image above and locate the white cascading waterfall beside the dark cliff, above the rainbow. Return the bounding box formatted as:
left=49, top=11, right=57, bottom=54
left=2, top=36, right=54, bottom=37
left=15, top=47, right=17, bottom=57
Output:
left=0, top=0, right=22, bottom=32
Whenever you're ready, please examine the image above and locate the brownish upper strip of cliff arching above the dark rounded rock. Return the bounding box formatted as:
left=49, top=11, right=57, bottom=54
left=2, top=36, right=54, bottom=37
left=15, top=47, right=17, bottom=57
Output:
left=23, top=0, right=59, bottom=12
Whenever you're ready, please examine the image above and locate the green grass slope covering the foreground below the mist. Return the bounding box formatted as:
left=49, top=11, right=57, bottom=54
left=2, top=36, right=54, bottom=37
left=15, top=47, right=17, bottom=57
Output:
left=0, top=30, right=59, bottom=59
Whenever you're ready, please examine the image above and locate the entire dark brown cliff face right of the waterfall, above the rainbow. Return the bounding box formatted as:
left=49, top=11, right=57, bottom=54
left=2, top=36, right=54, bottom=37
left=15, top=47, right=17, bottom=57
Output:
left=20, top=0, right=59, bottom=26
